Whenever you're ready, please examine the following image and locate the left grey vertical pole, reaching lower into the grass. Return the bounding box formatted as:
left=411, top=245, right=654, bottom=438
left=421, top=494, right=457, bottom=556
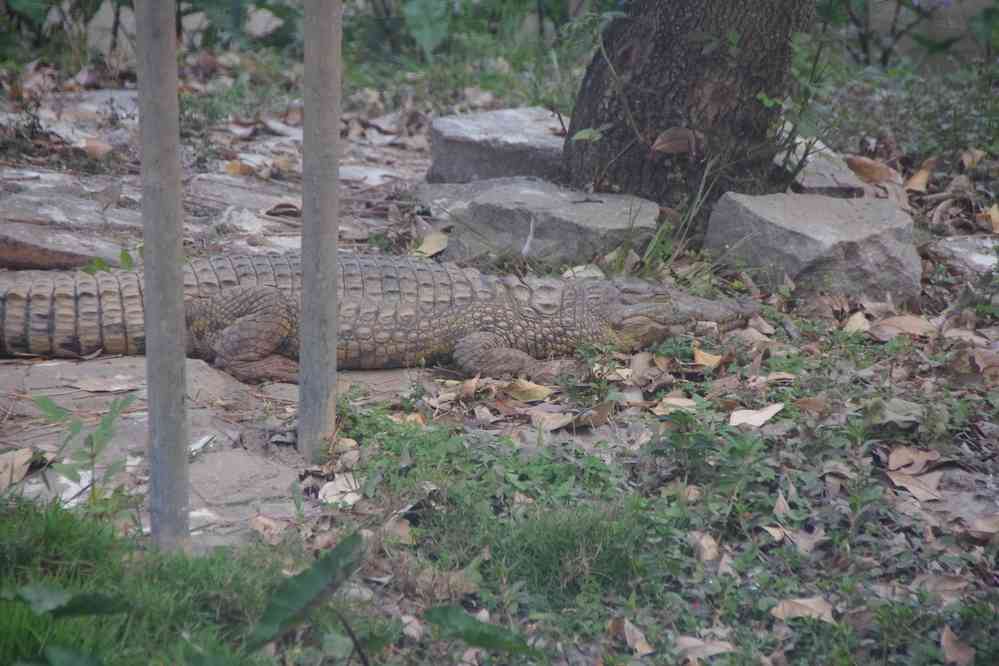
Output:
left=135, top=0, right=189, bottom=550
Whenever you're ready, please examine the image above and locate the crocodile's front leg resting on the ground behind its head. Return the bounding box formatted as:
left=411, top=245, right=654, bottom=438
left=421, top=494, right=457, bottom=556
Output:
left=454, top=333, right=589, bottom=383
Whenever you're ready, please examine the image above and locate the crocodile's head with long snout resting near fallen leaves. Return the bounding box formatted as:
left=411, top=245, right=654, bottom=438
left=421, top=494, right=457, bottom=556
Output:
left=590, top=280, right=759, bottom=351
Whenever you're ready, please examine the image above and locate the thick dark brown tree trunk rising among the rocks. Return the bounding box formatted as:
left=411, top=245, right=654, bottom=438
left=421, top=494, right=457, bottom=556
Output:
left=564, top=0, right=815, bottom=206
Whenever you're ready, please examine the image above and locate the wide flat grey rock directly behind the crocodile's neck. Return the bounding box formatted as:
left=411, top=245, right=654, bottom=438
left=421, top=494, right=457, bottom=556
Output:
left=415, top=178, right=659, bottom=265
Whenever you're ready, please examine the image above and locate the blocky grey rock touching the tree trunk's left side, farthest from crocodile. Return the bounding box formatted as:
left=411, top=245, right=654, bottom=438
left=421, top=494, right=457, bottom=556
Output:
left=427, top=107, right=565, bottom=183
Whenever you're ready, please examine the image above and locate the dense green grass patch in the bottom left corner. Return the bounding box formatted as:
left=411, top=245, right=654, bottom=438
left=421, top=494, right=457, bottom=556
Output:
left=0, top=502, right=281, bottom=664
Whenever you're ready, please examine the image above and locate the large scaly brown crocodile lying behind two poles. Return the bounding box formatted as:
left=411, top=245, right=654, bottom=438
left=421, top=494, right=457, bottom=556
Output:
left=0, top=253, right=758, bottom=381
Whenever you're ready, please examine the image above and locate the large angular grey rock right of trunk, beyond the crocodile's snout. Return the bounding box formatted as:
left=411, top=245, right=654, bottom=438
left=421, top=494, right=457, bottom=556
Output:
left=704, top=192, right=922, bottom=303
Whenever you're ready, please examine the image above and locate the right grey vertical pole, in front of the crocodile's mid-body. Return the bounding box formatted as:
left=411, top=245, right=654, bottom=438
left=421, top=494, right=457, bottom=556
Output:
left=298, top=0, right=343, bottom=462
